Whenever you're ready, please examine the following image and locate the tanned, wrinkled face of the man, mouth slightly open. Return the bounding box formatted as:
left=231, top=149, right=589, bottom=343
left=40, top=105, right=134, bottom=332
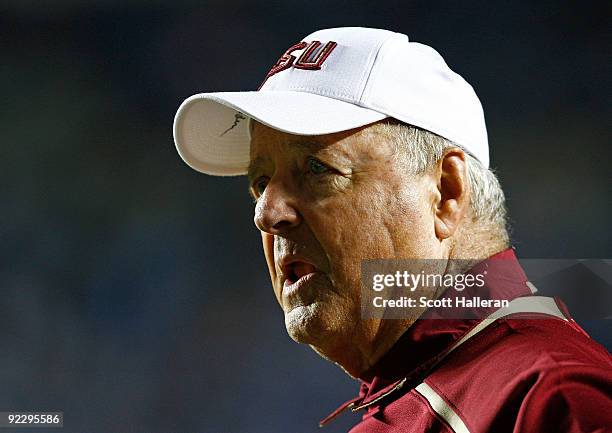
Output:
left=249, top=123, right=438, bottom=354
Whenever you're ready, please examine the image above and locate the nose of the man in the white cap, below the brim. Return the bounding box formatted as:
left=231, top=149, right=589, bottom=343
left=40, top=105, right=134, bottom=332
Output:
left=254, top=181, right=302, bottom=235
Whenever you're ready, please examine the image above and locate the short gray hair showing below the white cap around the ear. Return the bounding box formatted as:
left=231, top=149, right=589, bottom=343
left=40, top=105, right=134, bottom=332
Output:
left=376, top=119, right=509, bottom=244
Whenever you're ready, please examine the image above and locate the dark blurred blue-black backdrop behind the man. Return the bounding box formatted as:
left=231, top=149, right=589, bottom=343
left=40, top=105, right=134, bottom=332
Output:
left=0, top=0, right=612, bottom=433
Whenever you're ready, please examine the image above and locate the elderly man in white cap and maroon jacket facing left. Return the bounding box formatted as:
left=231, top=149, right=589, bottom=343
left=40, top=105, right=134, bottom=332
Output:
left=174, top=28, right=612, bottom=433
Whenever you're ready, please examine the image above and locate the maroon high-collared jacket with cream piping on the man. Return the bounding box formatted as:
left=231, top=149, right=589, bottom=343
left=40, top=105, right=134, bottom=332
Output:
left=321, top=249, right=612, bottom=433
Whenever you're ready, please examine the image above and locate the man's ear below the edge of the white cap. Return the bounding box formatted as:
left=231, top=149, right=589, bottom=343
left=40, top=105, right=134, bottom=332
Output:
left=434, top=148, right=470, bottom=240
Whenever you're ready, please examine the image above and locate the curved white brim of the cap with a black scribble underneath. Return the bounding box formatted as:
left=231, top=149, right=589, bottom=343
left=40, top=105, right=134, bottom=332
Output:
left=174, top=91, right=387, bottom=176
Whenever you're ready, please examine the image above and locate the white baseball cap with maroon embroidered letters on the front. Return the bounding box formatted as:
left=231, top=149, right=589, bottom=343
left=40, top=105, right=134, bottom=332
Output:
left=174, top=27, right=489, bottom=176
